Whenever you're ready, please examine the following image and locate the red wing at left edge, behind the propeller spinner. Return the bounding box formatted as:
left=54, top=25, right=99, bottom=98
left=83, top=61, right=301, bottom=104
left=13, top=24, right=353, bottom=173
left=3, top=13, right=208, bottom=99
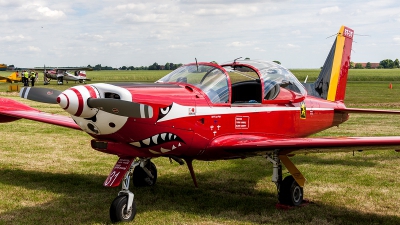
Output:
left=0, top=98, right=81, bottom=130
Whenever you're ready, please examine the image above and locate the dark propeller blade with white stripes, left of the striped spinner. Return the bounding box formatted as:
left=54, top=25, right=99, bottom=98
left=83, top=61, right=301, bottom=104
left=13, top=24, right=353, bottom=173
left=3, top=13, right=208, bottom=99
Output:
left=19, top=87, right=61, bottom=104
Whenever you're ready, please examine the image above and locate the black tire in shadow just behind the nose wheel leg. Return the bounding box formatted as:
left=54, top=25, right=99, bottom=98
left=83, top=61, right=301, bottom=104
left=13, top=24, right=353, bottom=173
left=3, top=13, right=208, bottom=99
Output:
left=132, top=162, right=157, bottom=187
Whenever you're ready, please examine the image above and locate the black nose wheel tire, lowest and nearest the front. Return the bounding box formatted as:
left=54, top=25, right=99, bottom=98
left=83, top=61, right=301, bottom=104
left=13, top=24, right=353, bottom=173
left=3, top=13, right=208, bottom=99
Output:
left=110, top=195, right=136, bottom=223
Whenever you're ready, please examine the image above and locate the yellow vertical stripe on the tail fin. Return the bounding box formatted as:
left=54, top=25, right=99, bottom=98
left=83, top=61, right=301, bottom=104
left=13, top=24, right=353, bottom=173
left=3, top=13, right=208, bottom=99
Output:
left=327, top=26, right=345, bottom=101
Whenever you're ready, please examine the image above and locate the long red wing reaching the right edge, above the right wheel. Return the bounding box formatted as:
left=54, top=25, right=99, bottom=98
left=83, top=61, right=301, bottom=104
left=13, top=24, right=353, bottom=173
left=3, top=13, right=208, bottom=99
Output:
left=207, top=134, right=400, bottom=155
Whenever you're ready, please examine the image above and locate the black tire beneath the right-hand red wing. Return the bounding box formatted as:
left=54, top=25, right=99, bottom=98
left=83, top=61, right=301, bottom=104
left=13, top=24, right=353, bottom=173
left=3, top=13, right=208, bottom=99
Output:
left=278, top=176, right=303, bottom=206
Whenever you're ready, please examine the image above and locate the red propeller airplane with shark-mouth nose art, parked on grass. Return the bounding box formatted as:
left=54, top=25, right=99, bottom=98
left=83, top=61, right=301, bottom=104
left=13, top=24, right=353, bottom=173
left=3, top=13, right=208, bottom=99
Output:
left=0, top=26, right=400, bottom=222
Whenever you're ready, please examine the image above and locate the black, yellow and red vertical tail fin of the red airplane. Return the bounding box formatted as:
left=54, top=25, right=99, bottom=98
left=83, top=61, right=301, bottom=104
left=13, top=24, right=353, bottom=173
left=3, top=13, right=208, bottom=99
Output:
left=305, top=26, right=354, bottom=101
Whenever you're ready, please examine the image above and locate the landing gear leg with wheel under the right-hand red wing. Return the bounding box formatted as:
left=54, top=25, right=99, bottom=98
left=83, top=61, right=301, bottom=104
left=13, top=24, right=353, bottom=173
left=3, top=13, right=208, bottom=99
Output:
left=266, top=151, right=305, bottom=206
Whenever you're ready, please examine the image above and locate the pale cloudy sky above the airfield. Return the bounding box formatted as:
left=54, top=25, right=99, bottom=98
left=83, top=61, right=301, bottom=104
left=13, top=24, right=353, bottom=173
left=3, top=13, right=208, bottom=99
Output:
left=0, top=0, right=400, bottom=69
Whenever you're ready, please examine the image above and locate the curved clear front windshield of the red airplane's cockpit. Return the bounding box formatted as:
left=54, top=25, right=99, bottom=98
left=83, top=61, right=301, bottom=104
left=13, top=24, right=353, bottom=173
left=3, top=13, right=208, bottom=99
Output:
left=157, top=64, right=229, bottom=103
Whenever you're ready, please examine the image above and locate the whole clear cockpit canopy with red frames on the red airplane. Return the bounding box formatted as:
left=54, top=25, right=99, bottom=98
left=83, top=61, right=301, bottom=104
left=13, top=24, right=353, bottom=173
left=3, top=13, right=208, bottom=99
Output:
left=157, top=60, right=307, bottom=104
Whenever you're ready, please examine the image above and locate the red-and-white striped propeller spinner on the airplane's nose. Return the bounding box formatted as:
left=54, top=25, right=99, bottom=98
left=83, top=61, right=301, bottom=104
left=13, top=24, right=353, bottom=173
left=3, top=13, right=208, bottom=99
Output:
left=57, top=85, right=99, bottom=118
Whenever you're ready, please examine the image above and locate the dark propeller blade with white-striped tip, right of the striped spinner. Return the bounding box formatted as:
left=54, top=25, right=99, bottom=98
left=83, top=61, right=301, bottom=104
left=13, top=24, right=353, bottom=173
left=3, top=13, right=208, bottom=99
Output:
left=87, top=98, right=153, bottom=118
